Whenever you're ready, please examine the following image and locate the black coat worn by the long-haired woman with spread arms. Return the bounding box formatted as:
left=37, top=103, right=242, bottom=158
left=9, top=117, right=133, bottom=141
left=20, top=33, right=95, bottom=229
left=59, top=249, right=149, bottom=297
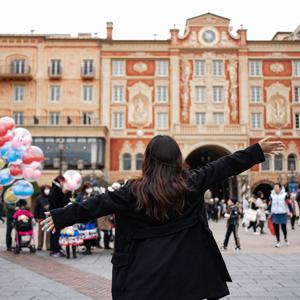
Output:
left=51, top=144, right=264, bottom=300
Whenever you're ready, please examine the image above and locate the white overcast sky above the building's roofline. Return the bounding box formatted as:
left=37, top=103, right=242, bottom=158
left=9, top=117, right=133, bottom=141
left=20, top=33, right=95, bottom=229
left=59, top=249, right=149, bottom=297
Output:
left=0, top=0, right=300, bottom=40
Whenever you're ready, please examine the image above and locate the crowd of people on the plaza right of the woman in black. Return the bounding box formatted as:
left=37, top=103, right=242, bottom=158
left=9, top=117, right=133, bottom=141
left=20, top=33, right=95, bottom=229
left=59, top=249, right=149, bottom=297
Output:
left=205, top=183, right=300, bottom=251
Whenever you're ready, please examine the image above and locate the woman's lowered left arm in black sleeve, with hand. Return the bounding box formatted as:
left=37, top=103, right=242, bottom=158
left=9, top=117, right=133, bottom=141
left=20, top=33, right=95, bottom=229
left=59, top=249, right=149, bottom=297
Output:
left=41, top=187, right=131, bottom=231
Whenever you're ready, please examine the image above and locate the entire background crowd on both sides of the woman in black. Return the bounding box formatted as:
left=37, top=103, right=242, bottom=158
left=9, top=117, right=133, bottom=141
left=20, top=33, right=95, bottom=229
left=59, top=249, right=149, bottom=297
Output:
left=0, top=176, right=300, bottom=258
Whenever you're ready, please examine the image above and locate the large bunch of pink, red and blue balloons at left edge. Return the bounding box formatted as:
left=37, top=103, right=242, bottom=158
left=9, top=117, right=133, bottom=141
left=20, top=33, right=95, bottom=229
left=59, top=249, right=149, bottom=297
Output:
left=0, top=117, right=44, bottom=203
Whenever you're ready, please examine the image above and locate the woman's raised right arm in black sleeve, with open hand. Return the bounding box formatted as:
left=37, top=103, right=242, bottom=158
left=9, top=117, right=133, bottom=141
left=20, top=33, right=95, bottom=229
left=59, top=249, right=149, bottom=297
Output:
left=191, top=137, right=284, bottom=190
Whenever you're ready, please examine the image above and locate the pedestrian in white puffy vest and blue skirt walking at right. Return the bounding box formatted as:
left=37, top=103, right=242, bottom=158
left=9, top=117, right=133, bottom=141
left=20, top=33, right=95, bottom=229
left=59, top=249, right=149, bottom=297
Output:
left=270, top=183, right=291, bottom=248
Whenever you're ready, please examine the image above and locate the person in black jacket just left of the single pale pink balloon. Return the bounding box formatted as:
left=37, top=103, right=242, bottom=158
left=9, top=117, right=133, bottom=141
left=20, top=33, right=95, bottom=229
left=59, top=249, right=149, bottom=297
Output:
left=49, top=175, right=69, bottom=257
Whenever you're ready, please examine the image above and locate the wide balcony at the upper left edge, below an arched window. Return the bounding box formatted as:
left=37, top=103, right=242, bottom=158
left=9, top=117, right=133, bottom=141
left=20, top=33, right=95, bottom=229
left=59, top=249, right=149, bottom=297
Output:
left=0, top=65, right=33, bottom=81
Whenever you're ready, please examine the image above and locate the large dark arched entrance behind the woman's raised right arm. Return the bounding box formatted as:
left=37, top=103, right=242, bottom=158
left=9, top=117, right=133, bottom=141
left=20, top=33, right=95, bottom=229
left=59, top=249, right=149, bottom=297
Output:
left=186, top=145, right=238, bottom=199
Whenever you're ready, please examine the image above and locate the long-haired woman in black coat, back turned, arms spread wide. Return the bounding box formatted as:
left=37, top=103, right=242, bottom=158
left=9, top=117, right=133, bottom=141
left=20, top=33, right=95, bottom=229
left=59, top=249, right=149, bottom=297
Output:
left=42, top=135, right=283, bottom=300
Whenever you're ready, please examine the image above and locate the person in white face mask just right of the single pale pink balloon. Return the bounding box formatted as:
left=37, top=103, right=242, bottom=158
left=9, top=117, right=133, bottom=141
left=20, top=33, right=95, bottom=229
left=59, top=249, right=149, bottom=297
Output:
left=76, top=182, right=98, bottom=255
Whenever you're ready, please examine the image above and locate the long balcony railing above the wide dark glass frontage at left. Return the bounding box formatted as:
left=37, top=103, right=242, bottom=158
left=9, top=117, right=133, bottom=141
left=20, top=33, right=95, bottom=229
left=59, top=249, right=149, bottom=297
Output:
left=9, top=116, right=101, bottom=126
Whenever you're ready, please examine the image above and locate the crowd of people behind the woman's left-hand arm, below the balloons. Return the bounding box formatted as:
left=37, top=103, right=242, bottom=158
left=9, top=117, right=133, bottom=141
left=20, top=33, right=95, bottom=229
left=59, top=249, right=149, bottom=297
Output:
left=2, top=175, right=118, bottom=259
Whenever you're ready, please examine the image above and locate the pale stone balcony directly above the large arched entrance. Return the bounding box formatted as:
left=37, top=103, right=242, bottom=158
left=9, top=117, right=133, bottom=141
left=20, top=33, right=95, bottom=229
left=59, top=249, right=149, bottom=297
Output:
left=174, top=124, right=247, bottom=136
